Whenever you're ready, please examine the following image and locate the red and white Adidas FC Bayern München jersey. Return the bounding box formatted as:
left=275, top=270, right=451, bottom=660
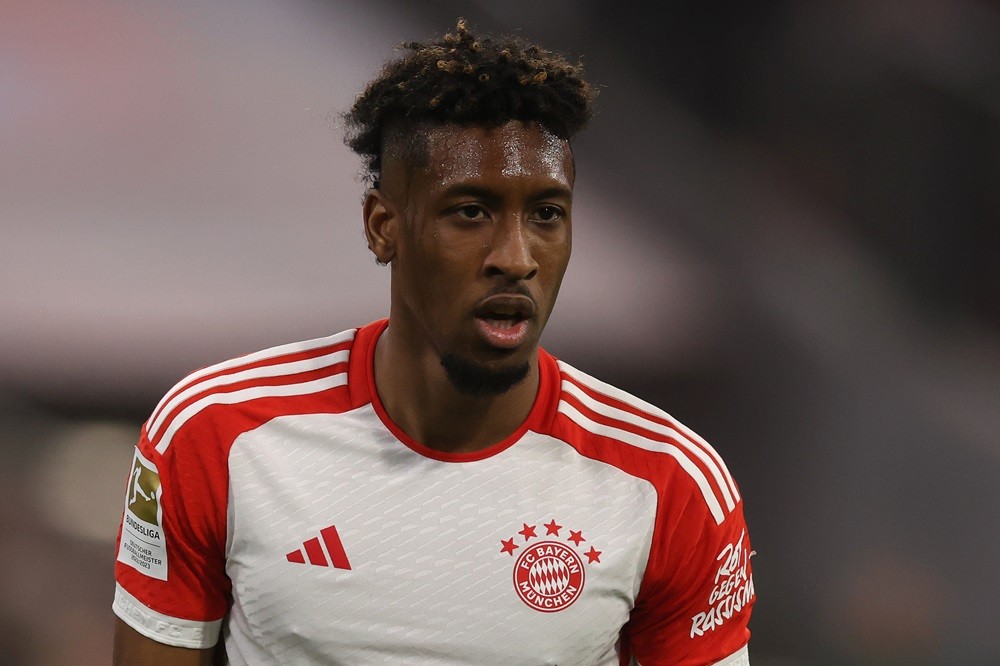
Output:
left=114, top=321, right=755, bottom=666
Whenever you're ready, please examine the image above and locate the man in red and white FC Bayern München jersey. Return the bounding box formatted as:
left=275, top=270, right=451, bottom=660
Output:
left=114, top=21, right=754, bottom=666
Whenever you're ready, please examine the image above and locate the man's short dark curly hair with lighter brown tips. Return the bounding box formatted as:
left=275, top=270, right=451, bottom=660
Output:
left=343, top=19, right=597, bottom=186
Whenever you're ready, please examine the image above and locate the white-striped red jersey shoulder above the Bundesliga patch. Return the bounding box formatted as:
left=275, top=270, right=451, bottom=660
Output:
left=143, top=329, right=358, bottom=454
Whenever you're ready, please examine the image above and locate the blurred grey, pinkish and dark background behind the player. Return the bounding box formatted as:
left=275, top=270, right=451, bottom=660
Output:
left=0, top=0, right=1000, bottom=666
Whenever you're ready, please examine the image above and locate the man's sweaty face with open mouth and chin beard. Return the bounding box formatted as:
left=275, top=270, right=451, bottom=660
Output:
left=366, top=122, right=574, bottom=393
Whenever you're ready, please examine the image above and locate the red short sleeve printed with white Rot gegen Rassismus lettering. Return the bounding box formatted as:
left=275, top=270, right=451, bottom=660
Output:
left=624, top=480, right=756, bottom=666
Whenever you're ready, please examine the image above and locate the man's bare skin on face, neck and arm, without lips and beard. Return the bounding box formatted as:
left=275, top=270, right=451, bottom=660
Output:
left=113, top=122, right=574, bottom=666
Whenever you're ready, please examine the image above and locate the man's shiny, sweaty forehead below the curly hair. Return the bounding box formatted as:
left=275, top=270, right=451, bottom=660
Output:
left=426, top=121, right=574, bottom=186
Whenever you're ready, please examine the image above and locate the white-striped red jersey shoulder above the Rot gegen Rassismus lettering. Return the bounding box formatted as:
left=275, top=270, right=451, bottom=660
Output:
left=553, top=361, right=740, bottom=524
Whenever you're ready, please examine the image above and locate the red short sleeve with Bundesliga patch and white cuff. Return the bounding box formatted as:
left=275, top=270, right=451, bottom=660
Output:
left=113, top=424, right=231, bottom=648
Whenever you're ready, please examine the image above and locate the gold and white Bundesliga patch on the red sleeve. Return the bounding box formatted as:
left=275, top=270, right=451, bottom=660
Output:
left=118, top=449, right=167, bottom=580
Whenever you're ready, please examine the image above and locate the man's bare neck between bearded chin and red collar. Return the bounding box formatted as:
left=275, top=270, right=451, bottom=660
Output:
left=375, top=321, right=539, bottom=453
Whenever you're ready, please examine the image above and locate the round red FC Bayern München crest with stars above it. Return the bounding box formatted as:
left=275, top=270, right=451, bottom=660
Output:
left=500, top=520, right=601, bottom=613
